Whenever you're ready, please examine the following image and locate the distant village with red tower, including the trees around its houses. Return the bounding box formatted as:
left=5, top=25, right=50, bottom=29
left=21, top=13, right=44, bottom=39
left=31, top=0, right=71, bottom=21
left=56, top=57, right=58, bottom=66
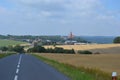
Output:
left=30, top=32, right=91, bottom=46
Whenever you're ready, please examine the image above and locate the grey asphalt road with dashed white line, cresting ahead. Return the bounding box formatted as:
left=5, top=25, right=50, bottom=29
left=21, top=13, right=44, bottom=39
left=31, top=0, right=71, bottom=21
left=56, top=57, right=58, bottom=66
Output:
left=0, top=54, right=70, bottom=80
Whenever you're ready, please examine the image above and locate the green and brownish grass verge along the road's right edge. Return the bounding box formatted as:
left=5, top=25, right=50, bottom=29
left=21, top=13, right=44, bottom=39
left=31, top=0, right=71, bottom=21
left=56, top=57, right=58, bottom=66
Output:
left=32, top=54, right=111, bottom=80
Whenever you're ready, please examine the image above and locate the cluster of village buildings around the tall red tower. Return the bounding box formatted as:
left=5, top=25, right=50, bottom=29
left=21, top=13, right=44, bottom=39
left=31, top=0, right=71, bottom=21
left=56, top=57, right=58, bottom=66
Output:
left=31, top=32, right=88, bottom=46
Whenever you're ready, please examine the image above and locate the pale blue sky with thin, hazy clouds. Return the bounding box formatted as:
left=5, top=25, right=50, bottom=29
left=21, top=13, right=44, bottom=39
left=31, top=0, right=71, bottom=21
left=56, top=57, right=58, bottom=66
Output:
left=0, top=0, right=120, bottom=36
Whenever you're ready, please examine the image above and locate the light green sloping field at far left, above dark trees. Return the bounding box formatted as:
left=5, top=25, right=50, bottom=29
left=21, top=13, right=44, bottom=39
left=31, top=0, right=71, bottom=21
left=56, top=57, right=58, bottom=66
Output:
left=0, top=39, right=25, bottom=47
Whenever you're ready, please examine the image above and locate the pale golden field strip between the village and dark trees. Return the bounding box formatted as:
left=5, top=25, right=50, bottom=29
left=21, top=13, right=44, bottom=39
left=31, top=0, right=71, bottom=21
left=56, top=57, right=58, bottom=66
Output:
left=44, top=44, right=120, bottom=50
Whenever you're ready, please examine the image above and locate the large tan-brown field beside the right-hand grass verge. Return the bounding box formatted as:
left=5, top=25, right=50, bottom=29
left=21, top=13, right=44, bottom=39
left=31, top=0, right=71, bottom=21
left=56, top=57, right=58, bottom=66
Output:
left=38, top=53, right=120, bottom=75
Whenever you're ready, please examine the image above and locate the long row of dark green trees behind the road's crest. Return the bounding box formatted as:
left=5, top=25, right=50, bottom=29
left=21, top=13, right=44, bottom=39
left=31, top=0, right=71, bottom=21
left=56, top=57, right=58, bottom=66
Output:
left=0, top=45, right=75, bottom=54
